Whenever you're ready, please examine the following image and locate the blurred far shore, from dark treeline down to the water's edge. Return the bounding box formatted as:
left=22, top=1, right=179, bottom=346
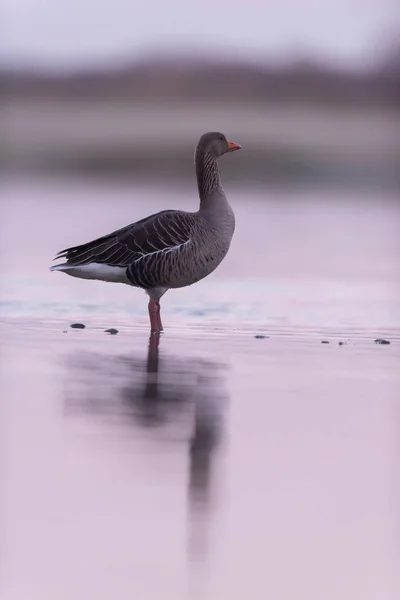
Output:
left=0, top=60, right=400, bottom=189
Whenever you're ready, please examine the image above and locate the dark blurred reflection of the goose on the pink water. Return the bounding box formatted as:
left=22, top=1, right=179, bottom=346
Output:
left=65, top=335, right=228, bottom=558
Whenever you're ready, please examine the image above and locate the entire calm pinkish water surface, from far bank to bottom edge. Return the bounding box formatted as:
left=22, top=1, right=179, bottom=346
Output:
left=0, top=176, right=400, bottom=600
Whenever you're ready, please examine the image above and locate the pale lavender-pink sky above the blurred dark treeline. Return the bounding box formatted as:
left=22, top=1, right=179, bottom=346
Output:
left=0, top=0, right=400, bottom=67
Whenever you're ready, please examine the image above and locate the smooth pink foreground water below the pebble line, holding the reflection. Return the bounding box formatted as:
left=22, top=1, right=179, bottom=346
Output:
left=1, top=321, right=400, bottom=600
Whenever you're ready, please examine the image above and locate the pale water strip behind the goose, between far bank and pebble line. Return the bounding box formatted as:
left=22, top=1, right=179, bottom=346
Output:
left=0, top=180, right=400, bottom=333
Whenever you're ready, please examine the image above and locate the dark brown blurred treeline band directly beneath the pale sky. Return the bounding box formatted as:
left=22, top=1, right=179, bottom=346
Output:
left=0, top=54, right=400, bottom=107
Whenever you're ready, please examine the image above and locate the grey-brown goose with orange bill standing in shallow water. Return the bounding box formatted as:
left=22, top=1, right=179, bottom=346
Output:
left=50, top=132, right=240, bottom=333
